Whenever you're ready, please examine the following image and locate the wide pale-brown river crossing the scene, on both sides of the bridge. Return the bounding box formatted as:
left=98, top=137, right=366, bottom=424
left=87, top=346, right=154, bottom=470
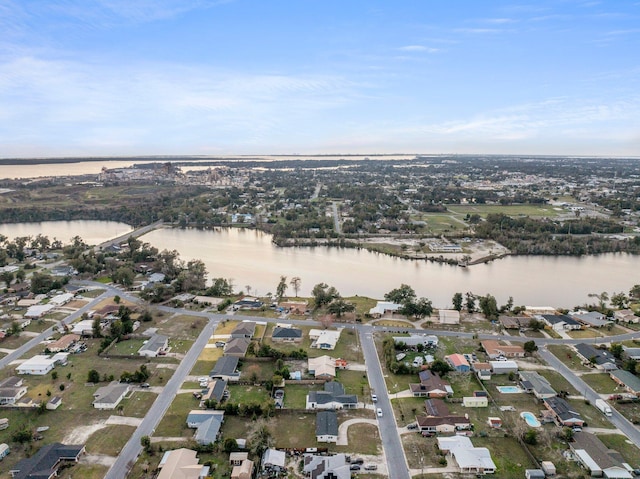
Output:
left=0, top=221, right=640, bottom=308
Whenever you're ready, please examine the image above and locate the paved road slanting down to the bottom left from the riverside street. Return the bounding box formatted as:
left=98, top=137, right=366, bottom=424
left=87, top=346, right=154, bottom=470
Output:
left=104, top=318, right=219, bottom=479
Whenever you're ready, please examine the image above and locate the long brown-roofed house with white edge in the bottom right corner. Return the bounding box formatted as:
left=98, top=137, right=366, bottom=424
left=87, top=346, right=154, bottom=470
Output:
left=569, top=432, right=634, bottom=479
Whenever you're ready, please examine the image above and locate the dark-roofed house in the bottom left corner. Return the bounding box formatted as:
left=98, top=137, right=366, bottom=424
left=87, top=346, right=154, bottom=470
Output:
left=9, top=442, right=85, bottom=479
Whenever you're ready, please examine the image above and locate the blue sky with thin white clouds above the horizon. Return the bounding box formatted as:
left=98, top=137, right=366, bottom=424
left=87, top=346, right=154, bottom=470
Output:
left=0, top=0, right=640, bottom=157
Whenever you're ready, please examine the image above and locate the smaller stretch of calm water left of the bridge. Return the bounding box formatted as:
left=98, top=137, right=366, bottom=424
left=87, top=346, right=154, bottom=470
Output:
left=0, top=221, right=133, bottom=245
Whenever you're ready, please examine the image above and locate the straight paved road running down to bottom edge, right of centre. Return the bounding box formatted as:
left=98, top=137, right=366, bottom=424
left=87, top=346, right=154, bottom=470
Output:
left=358, top=326, right=411, bottom=479
